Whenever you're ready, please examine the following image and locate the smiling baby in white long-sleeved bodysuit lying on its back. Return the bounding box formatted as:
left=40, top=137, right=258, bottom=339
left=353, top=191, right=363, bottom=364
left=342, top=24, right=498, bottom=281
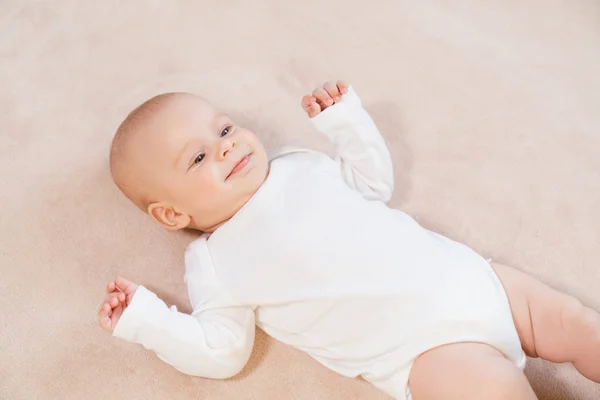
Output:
left=98, top=81, right=600, bottom=400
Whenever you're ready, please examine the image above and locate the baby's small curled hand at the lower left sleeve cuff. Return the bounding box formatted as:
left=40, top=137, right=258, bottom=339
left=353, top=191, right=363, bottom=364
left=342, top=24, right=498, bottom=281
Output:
left=98, top=277, right=138, bottom=333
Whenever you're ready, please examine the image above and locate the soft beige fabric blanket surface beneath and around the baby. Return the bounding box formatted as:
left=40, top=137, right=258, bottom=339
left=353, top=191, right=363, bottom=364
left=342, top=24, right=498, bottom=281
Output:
left=0, top=0, right=600, bottom=400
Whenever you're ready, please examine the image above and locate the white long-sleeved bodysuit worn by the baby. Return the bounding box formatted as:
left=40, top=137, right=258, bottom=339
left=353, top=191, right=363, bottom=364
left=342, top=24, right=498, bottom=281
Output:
left=114, top=88, right=525, bottom=399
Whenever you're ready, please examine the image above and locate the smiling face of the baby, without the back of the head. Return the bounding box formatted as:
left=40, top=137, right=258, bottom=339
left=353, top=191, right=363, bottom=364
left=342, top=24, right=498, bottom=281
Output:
left=136, top=95, right=268, bottom=232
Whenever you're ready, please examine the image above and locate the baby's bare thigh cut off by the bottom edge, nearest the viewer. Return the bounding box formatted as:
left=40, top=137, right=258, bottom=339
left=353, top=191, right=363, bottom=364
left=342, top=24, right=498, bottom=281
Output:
left=409, top=343, right=536, bottom=400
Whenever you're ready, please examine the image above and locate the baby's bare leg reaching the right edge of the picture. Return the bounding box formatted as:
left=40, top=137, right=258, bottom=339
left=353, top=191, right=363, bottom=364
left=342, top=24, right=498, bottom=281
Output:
left=492, top=264, right=600, bottom=382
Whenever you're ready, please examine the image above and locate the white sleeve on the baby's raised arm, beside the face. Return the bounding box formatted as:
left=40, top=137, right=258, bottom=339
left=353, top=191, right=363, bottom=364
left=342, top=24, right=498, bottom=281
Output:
left=312, top=87, right=394, bottom=202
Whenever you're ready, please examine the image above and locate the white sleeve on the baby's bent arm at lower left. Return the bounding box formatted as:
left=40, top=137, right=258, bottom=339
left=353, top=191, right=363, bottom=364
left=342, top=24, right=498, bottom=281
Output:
left=113, top=239, right=255, bottom=379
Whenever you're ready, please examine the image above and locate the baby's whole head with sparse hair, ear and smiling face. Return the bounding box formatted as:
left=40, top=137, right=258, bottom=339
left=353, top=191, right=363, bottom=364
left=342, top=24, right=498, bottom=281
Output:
left=110, top=93, right=269, bottom=232
